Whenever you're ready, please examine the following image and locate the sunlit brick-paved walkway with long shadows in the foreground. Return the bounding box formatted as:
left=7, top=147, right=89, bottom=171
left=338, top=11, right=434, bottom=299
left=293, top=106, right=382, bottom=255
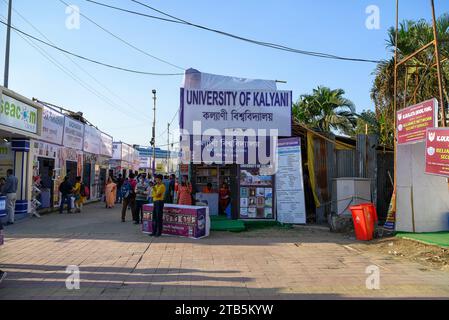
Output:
left=0, top=204, right=449, bottom=300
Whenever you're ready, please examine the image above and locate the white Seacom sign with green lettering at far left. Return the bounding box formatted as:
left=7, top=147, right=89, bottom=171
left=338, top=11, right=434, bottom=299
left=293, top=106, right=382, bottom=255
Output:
left=0, top=92, right=39, bottom=134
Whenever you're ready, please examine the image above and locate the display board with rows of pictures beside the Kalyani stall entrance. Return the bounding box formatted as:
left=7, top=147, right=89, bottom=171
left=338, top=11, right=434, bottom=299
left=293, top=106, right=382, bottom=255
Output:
left=240, top=165, right=275, bottom=219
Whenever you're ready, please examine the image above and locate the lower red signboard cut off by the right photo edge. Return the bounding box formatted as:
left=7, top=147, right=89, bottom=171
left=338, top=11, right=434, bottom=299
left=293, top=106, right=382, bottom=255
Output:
left=426, top=128, right=449, bottom=176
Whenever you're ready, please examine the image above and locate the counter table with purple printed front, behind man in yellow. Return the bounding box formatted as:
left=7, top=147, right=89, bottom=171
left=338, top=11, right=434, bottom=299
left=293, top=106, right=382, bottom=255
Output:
left=142, top=204, right=210, bottom=239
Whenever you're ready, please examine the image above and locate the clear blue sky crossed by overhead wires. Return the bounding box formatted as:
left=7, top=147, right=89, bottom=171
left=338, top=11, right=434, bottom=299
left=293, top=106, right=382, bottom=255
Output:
left=0, top=0, right=449, bottom=145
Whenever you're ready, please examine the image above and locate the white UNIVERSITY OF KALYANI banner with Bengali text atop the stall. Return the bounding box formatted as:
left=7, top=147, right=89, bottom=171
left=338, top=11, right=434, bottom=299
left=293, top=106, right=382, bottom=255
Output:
left=180, top=88, right=292, bottom=137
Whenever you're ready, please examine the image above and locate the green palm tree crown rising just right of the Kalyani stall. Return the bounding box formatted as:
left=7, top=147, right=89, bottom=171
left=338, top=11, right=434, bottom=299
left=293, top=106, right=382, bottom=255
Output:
left=293, top=86, right=357, bottom=134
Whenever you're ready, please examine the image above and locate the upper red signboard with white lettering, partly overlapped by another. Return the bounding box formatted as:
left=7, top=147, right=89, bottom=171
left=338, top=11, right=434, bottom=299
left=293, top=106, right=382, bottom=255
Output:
left=397, top=99, right=438, bottom=144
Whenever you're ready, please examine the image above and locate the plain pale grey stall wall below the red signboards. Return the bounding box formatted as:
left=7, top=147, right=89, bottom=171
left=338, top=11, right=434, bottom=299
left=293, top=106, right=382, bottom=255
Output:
left=396, top=142, right=449, bottom=232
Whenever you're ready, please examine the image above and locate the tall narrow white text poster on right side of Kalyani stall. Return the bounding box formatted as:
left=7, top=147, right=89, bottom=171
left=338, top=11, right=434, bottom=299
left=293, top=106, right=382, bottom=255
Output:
left=276, top=138, right=306, bottom=224
